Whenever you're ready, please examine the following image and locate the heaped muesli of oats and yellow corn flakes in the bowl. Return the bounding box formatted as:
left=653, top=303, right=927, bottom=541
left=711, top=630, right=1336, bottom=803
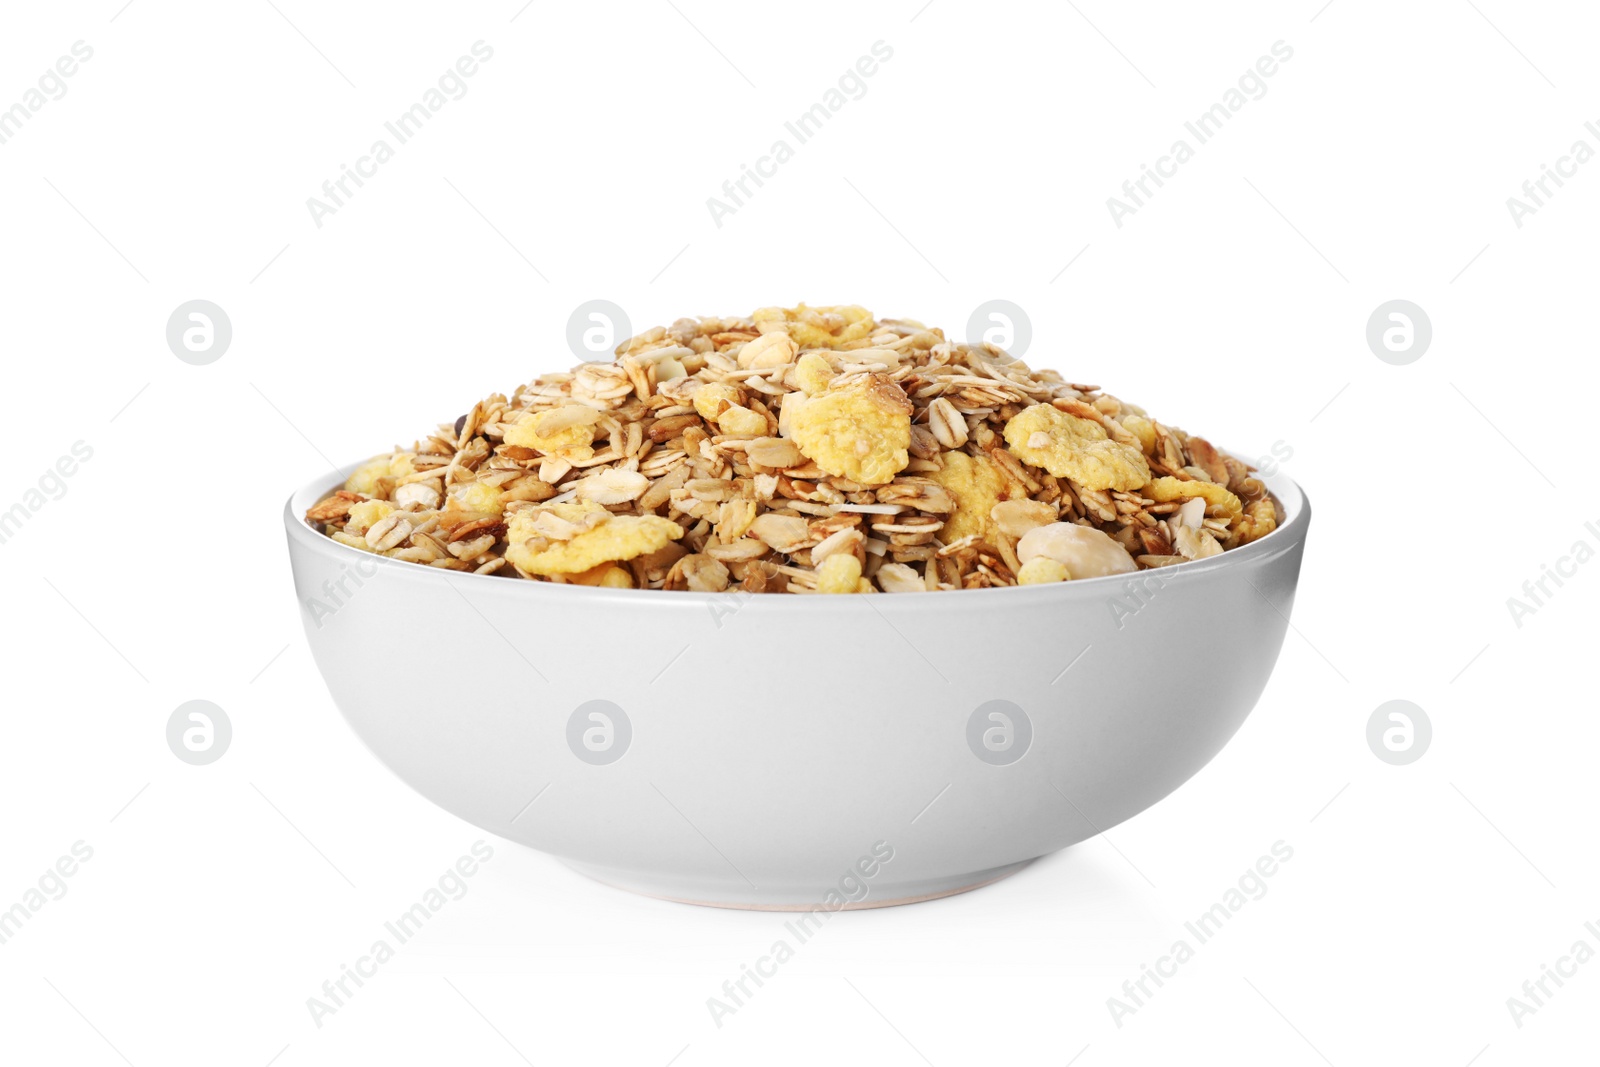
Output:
left=306, top=304, right=1280, bottom=593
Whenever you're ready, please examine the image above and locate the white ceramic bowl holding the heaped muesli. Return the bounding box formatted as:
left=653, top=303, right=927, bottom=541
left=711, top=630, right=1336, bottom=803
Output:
left=283, top=460, right=1310, bottom=910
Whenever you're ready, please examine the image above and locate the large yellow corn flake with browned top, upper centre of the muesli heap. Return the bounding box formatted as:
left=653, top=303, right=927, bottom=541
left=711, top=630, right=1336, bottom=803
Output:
left=782, top=376, right=912, bottom=485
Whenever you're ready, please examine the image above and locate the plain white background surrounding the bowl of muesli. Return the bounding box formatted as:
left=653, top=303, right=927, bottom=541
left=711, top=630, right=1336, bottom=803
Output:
left=0, top=0, right=1600, bottom=1067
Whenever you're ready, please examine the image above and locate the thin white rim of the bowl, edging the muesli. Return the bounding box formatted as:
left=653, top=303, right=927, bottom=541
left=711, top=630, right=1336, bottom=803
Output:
left=283, top=453, right=1310, bottom=611
